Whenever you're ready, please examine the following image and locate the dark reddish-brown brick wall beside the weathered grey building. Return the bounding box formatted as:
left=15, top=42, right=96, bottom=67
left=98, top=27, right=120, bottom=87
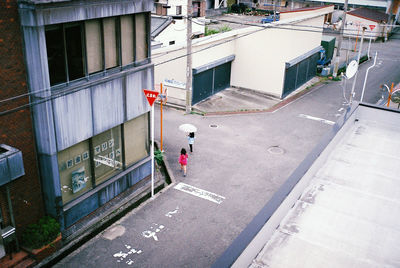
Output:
left=0, top=0, right=44, bottom=237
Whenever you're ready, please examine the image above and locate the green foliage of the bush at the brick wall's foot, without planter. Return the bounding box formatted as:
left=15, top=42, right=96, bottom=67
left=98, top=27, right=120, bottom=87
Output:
left=22, top=216, right=60, bottom=248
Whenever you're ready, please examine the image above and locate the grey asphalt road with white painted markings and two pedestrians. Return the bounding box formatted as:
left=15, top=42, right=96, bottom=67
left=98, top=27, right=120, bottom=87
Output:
left=56, top=34, right=400, bottom=267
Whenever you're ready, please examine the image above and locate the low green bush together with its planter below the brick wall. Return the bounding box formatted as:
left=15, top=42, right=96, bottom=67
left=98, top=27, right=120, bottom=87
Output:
left=22, top=216, right=61, bottom=261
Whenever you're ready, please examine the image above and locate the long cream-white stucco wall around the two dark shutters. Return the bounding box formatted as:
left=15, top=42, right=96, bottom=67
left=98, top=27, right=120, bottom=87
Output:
left=152, top=6, right=332, bottom=101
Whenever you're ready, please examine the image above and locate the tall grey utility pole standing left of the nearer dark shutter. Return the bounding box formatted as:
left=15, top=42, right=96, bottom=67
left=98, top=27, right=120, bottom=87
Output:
left=186, top=0, right=193, bottom=114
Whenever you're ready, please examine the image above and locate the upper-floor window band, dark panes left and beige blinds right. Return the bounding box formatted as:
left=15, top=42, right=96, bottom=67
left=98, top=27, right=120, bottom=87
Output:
left=45, top=12, right=150, bottom=86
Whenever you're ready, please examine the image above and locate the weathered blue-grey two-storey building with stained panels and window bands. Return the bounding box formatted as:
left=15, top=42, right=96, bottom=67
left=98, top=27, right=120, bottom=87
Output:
left=13, top=0, right=154, bottom=237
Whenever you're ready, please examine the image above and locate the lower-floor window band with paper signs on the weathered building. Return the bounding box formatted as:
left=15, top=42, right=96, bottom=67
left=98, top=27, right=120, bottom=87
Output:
left=58, top=113, right=150, bottom=204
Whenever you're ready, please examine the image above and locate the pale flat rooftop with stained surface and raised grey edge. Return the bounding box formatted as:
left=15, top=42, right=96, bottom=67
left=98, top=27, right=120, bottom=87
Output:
left=217, top=104, right=400, bottom=268
